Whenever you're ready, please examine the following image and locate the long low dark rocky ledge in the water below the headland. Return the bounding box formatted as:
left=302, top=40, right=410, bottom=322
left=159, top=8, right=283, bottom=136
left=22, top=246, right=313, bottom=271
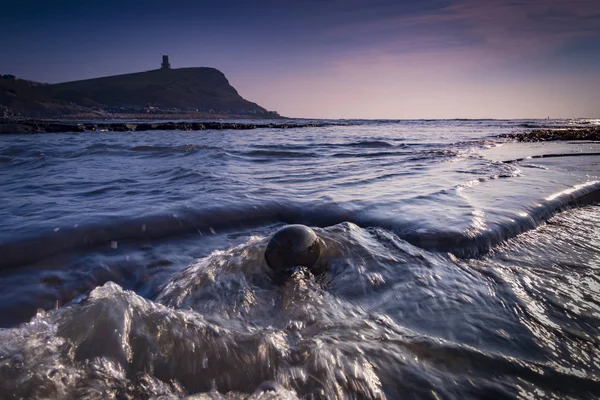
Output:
left=0, top=119, right=332, bottom=134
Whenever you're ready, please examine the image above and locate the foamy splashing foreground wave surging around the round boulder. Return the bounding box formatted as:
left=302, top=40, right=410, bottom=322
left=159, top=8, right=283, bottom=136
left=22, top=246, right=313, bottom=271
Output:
left=0, top=216, right=600, bottom=399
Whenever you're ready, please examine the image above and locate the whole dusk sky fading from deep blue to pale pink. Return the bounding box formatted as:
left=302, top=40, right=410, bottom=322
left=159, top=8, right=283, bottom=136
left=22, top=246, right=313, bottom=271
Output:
left=0, top=0, right=600, bottom=119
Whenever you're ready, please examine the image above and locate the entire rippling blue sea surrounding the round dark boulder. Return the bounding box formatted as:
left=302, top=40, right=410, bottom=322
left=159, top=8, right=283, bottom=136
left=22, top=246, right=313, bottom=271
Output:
left=0, top=120, right=600, bottom=399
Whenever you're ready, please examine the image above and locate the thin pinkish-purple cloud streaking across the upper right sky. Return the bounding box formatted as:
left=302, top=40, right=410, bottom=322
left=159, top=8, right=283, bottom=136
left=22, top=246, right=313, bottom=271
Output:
left=318, top=0, right=600, bottom=57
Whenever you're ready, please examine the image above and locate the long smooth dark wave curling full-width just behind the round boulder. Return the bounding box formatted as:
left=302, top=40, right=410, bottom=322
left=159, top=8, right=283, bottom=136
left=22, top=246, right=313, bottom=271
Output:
left=0, top=181, right=600, bottom=269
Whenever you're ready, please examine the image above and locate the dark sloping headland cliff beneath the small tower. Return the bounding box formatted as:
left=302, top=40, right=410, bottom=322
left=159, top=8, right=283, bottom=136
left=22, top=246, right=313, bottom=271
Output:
left=0, top=67, right=274, bottom=117
